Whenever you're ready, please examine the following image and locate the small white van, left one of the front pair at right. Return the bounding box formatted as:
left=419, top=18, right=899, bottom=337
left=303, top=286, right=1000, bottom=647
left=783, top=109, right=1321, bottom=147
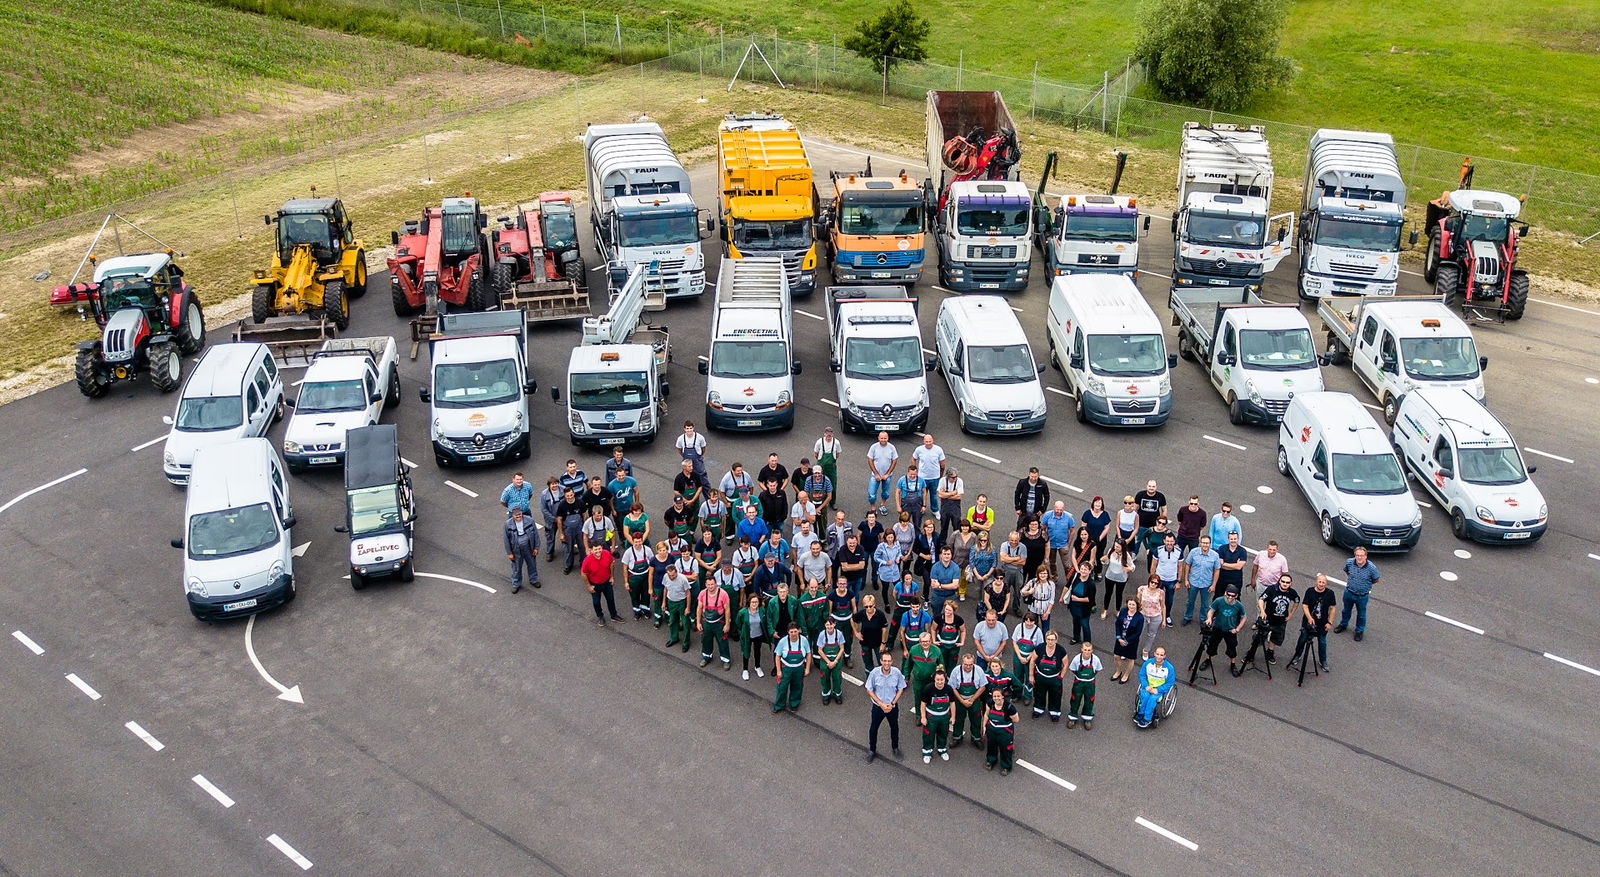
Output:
left=1278, top=390, right=1422, bottom=552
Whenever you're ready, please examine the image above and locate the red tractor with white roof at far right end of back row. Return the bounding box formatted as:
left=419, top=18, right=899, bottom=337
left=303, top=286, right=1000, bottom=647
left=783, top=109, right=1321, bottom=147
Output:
left=1422, top=162, right=1528, bottom=322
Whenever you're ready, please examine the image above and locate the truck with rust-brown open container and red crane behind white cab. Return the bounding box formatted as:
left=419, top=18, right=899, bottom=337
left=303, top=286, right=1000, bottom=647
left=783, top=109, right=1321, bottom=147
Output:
left=926, top=91, right=1034, bottom=293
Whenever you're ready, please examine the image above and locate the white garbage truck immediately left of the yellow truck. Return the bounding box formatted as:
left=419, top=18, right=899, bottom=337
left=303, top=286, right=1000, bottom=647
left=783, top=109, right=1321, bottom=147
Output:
left=584, top=122, right=706, bottom=299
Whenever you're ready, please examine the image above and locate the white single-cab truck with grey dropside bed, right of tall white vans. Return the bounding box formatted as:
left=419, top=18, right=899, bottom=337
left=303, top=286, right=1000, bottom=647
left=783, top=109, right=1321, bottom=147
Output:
left=1166, top=286, right=1325, bottom=426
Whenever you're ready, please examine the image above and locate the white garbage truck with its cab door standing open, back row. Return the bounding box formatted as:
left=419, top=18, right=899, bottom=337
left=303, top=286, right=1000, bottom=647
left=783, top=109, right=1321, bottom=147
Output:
left=1173, top=122, right=1294, bottom=290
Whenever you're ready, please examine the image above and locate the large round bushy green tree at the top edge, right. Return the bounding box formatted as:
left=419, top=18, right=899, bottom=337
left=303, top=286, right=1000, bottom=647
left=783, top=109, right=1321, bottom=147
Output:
left=1134, top=0, right=1294, bottom=110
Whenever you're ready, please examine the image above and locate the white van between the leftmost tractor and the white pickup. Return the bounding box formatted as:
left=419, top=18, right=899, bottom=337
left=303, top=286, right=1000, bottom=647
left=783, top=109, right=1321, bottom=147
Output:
left=162, top=342, right=283, bottom=485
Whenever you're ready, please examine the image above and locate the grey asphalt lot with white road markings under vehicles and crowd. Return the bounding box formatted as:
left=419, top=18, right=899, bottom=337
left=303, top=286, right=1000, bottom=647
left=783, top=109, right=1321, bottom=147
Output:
left=0, top=133, right=1600, bottom=874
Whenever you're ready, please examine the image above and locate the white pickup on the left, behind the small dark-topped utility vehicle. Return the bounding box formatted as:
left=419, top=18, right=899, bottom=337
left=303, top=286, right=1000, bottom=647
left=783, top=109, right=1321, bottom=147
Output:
left=283, top=336, right=400, bottom=472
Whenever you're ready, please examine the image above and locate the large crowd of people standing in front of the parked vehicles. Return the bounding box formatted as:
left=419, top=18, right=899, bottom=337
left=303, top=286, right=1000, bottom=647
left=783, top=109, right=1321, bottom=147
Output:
left=501, top=422, right=1378, bottom=773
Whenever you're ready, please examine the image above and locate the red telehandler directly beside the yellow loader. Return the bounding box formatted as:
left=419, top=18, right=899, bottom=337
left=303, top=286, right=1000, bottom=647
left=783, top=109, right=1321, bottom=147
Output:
left=389, top=194, right=494, bottom=317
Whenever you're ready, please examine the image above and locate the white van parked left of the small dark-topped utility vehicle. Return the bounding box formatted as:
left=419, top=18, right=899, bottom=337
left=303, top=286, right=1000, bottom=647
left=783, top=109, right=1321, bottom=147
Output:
left=173, top=439, right=294, bottom=621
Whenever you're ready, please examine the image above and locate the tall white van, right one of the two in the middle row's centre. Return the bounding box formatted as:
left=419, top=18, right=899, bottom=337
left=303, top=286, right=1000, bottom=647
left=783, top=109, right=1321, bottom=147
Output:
left=1048, top=274, right=1178, bottom=426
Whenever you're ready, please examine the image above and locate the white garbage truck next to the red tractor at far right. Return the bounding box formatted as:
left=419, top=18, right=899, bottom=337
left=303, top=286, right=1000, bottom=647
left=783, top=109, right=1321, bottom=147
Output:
left=1299, top=128, right=1405, bottom=301
